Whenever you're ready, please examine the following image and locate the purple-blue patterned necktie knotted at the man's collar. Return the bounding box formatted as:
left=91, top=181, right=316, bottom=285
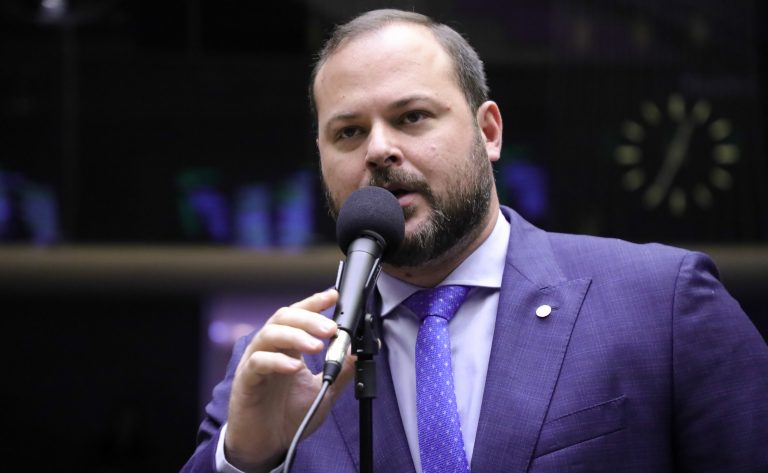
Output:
left=403, top=286, right=469, bottom=473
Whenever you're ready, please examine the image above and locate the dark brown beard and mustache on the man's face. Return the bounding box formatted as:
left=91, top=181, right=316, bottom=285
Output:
left=323, top=129, right=494, bottom=267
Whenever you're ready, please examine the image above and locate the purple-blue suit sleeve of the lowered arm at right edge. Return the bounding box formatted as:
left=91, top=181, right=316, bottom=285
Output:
left=672, top=249, right=768, bottom=473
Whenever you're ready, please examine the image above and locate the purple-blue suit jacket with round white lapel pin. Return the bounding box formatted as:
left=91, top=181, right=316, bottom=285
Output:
left=183, top=208, right=768, bottom=473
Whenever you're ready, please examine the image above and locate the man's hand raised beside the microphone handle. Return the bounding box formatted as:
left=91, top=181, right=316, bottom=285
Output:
left=224, top=290, right=354, bottom=472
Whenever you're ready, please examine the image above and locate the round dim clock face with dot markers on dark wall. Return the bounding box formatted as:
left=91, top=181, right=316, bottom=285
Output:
left=613, top=93, right=740, bottom=217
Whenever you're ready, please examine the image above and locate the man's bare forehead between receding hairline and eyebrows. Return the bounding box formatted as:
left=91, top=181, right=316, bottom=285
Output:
left=313, top=23, right=461, bottom=119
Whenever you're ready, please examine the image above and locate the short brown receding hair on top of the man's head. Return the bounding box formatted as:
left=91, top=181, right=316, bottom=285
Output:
left=309, top=9, right=488, bottom=119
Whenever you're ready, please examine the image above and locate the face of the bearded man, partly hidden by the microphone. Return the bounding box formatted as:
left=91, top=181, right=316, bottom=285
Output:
left=314, top=23, right=494, bottom=266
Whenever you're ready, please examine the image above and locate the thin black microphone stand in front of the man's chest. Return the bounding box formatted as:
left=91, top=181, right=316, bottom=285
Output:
left=352, top=312, right=381, bottom=473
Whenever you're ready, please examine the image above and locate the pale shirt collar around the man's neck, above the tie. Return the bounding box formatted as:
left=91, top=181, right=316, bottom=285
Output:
left=376, top=212, right=509, bottom=316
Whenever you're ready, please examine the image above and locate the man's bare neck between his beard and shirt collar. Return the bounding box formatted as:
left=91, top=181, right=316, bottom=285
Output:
left=382, top=199, right=499, bottom=287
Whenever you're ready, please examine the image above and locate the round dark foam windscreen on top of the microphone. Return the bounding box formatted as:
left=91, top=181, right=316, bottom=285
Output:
left=336, top=186, right=405, bottom=259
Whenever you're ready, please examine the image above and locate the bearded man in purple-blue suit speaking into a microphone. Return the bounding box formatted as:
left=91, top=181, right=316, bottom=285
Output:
left=184, top=10, right=768, bottom=473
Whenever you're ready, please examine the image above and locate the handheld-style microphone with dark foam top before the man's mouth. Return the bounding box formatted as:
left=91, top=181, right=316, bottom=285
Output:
left=323, top=187, right=405, bottom=383
